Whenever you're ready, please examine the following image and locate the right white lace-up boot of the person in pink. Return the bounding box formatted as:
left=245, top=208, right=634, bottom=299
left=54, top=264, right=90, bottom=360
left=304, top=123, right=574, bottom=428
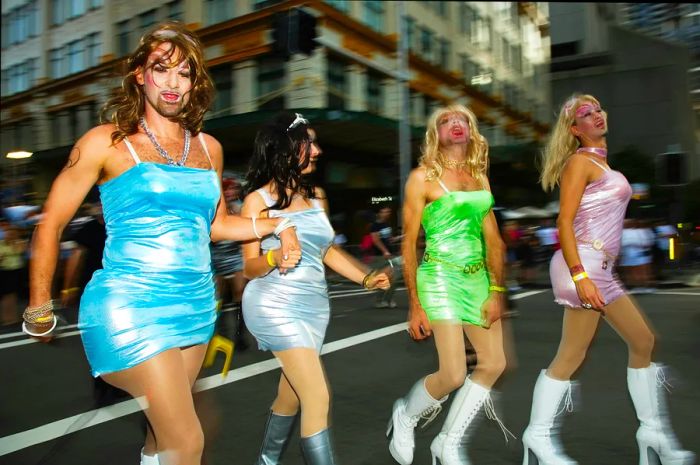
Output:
left=627, top=363, right=695, bottom=465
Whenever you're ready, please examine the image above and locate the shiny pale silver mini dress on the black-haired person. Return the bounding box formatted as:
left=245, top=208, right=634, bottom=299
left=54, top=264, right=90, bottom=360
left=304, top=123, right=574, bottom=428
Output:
left=243, top=189, right=333, bottom=352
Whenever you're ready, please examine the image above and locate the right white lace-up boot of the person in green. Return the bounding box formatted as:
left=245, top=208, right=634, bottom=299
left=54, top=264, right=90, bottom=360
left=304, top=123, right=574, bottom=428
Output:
left=430, top=378, right=515, bottom=465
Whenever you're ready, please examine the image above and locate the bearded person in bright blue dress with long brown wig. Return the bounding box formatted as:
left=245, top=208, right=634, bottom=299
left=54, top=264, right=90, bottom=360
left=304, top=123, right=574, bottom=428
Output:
left=23, top=22, right=301, bottom=465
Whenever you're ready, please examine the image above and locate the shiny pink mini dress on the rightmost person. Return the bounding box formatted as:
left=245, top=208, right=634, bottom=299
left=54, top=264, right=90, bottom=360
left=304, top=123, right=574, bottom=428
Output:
left=549, top=158, right=632, bottom=308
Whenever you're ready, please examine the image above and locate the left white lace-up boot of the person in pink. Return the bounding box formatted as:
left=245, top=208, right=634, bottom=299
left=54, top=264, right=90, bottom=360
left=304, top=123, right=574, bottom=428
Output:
left=523, top=370, right=576, bottom=465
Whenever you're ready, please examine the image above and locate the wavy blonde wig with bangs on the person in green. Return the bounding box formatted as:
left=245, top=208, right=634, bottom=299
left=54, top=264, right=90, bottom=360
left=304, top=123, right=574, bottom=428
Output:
left=418, top=104, right=489, bottom=187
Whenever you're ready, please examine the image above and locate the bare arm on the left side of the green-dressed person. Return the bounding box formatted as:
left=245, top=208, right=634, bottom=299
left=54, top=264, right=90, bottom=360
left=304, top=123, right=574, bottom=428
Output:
left=401, top=168, right=431, bottom=340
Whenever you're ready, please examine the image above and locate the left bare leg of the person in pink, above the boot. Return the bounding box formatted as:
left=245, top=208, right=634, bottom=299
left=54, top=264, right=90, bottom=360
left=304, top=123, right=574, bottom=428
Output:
left=547, top=307, right=600, bottom=381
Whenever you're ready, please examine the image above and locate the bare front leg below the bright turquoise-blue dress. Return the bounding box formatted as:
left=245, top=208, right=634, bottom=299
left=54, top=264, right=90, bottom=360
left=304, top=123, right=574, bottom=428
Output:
left=102, top=346, right=204, bottom=465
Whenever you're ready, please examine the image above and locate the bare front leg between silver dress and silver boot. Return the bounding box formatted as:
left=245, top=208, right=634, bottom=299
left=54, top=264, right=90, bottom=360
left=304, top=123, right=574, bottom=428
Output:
left=273, top=348, right=330, bottom=437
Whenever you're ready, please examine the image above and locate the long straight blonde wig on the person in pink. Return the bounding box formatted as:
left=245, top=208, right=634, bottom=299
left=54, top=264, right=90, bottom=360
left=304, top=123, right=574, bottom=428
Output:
left=540, top=94, right=600, bottom=191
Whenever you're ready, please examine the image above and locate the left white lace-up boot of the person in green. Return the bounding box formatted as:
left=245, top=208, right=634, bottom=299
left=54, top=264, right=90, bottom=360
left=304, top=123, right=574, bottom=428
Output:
left=386, top=378, right=447, bottom=465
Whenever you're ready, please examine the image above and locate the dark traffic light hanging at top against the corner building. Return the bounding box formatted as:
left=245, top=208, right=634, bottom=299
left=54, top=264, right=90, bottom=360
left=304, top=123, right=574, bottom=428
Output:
left=272, top=8, right=317, bottom=58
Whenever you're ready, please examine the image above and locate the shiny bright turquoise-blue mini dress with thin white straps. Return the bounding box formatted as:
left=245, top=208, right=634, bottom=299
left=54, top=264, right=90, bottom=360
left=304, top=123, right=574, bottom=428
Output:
left=78, top=134, right=221, bottom=377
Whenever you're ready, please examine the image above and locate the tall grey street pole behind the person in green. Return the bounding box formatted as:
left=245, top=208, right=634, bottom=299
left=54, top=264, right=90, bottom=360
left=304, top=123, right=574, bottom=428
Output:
left=396, top=0, right=411, bottom=227
